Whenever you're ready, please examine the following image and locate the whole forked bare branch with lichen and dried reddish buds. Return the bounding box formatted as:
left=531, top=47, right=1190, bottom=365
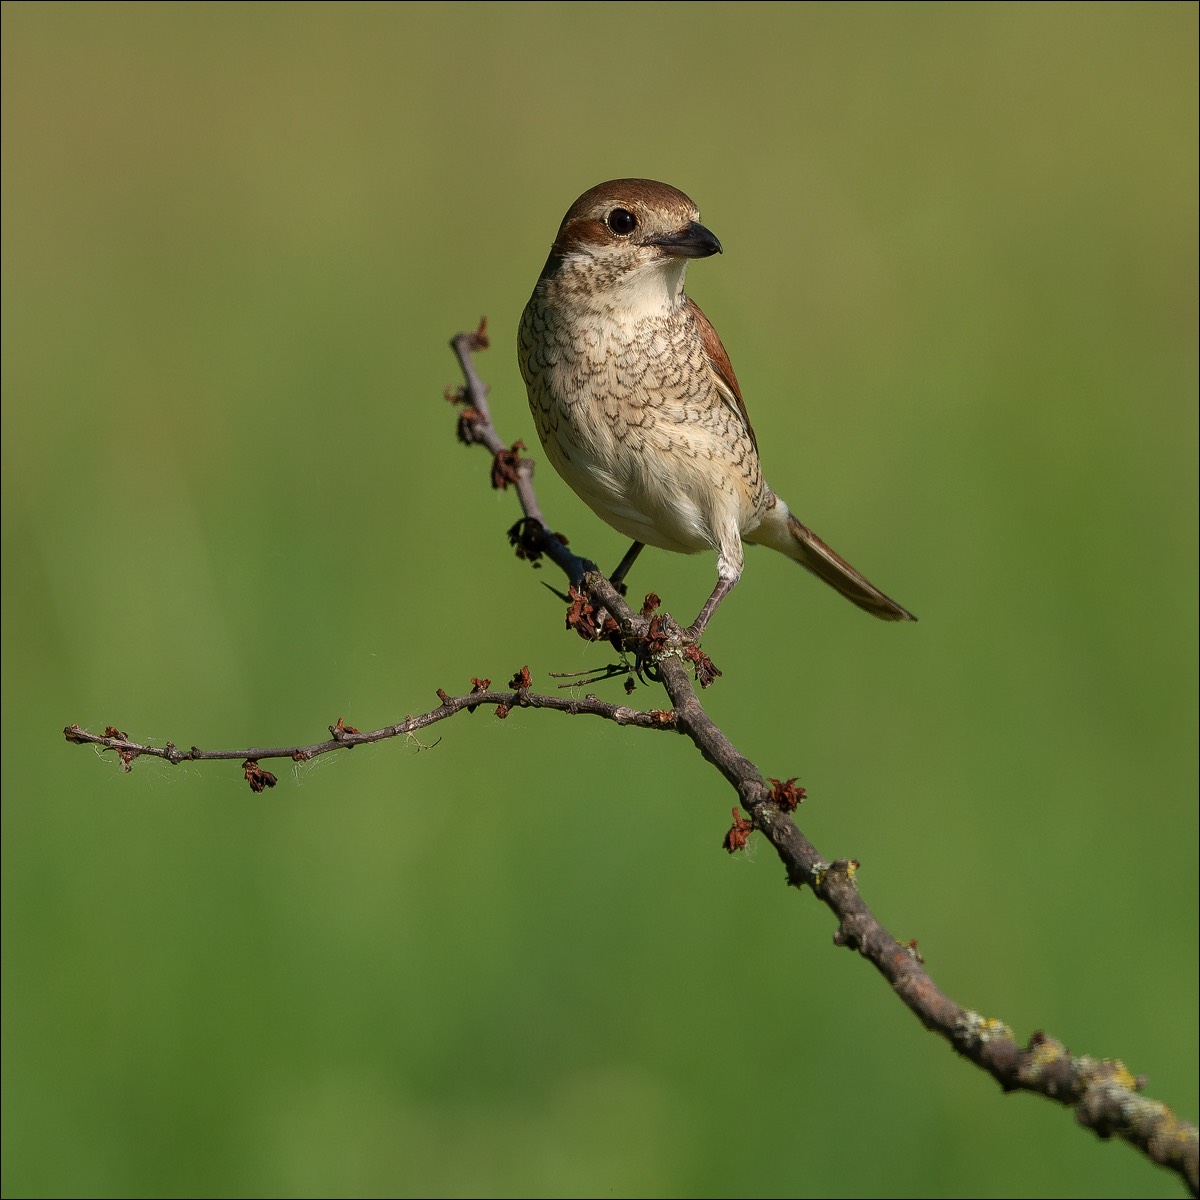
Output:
left=64, top=322, right=1200, bottom=1195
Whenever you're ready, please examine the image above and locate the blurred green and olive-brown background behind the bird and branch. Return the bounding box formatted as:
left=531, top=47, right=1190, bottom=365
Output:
left=2, top=4, right=1198, bottom=1196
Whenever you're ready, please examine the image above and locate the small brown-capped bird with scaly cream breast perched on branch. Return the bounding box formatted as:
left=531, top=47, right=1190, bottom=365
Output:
left=517, top=179, right=916, bottom=642
